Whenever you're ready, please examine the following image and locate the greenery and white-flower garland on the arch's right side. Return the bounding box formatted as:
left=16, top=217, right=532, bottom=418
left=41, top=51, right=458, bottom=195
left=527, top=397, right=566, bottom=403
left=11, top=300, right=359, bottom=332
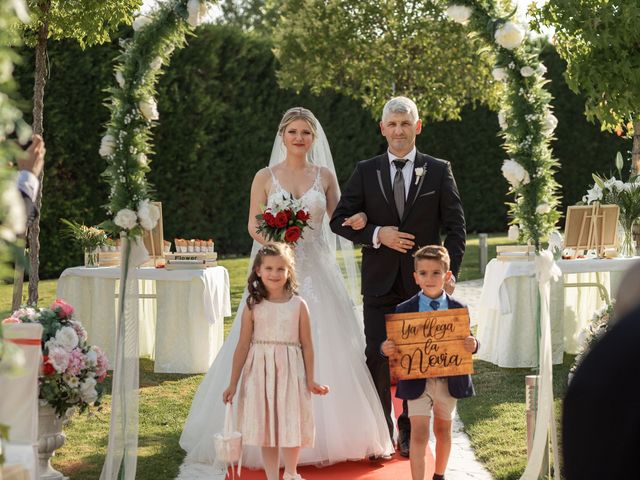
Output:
left=447, top=0, right=560, bottom=250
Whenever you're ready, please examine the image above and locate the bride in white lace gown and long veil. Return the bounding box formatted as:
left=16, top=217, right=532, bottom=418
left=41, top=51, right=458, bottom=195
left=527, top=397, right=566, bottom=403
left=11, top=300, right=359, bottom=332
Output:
left=179, top=108, right=394, bottom=479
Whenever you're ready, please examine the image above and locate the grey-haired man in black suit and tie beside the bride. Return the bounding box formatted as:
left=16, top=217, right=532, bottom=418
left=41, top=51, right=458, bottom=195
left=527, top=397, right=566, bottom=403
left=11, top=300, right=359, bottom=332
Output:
left=331, top=97, right=466, bottom=456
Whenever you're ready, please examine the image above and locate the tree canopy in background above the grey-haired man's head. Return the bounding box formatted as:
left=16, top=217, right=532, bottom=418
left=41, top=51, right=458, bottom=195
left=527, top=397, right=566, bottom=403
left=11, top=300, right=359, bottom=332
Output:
left=273, top=0, right=498, bottom=120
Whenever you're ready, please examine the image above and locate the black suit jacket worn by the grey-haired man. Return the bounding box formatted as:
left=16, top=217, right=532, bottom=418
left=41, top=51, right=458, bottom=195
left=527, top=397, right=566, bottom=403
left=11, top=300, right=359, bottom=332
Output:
left=331, top=152, right=466, bottom=296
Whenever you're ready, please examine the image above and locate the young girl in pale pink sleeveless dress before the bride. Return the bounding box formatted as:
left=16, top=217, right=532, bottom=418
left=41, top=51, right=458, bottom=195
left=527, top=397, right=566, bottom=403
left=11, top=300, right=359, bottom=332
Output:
left=222, top=243, right=329, bottom=480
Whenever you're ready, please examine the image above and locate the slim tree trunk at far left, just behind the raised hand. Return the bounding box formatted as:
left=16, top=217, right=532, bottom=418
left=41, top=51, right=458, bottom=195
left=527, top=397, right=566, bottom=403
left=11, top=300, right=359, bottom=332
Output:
left=28, top=0, right=51, bottom=306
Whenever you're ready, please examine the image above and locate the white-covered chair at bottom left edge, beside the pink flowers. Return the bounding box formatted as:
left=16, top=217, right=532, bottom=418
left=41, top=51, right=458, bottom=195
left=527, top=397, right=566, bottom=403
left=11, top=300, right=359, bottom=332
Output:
left=0, top=323, right=42, bottom=480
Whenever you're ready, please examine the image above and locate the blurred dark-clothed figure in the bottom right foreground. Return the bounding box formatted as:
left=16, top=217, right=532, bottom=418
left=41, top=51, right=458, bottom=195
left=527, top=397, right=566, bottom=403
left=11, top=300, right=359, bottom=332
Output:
left=562, top=307, right=640, bottom=480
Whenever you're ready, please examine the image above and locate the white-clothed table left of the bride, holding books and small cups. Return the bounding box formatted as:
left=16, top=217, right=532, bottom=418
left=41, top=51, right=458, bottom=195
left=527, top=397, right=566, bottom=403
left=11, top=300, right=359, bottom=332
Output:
left=57, top=266, right=231, bottom=373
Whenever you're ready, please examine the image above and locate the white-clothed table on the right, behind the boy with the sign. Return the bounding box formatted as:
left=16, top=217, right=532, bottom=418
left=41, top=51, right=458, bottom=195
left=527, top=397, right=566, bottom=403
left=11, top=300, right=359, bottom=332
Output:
left=476, top=257, right=638, bottom=368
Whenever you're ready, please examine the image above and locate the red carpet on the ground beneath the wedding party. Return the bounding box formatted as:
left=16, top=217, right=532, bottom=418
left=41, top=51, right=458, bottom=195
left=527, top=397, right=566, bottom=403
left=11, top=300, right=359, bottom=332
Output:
left=235, top=392, right=434, bottom=480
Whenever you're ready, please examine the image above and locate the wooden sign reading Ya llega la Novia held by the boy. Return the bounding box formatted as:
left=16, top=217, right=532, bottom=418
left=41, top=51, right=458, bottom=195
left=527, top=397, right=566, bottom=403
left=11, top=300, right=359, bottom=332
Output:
left=385, top=308, right=473, bottom=380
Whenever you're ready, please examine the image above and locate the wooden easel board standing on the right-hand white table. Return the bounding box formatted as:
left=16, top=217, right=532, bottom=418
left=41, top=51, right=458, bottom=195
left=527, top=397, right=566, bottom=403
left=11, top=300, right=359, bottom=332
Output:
left=564, top=202, right=620, bottom=259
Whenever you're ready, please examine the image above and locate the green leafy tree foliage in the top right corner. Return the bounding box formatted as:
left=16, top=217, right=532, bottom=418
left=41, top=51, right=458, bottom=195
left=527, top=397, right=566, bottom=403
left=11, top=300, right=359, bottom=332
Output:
left=531, top=0, right=640, bottom=133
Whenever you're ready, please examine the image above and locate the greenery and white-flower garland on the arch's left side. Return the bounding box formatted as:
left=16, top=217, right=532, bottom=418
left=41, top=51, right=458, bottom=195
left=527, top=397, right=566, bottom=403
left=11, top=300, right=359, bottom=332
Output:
left=99, top=0, right=207, bottom=238
